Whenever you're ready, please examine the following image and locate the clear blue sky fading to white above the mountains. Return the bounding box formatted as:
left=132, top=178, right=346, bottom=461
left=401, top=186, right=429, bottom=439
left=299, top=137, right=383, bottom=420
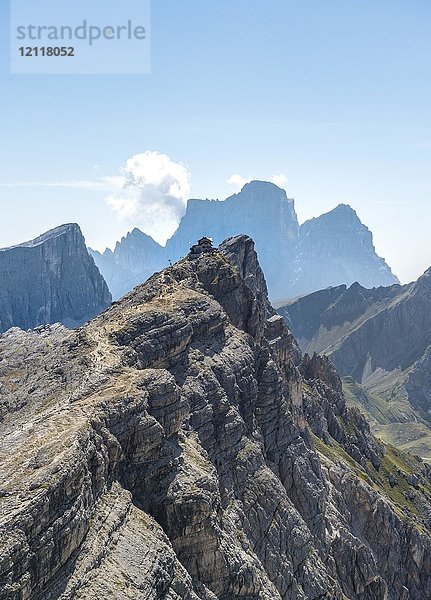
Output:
left=0, top=0, right=431, bottom=281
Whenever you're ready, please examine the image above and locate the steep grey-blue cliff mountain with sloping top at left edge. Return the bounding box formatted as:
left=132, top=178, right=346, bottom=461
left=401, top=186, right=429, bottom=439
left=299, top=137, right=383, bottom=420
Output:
left=0, top=224, right=111, bottom=331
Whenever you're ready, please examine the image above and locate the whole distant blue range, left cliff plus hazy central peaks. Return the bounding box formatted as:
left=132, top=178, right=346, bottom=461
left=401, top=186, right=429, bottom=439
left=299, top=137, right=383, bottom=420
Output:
left=0, top=181, right=397, bottom=332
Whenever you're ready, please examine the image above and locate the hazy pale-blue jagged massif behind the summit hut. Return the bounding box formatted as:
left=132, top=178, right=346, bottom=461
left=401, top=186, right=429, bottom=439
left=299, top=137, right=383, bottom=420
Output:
left=90, top=181, right=398, bottom=300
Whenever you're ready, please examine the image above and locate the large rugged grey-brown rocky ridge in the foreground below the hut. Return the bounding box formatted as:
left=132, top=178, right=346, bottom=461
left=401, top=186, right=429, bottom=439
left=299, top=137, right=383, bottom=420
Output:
left=0, top=236, right=431, bottom=600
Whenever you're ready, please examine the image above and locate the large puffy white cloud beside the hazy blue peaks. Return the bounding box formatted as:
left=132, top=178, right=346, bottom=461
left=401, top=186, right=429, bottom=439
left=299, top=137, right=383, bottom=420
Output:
left=106, top=150, right=191, bottom=243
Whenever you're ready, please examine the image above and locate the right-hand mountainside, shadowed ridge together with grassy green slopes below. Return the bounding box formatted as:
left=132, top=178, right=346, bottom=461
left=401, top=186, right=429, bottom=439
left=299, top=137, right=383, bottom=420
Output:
left=278, top=269, right=431, bottom=459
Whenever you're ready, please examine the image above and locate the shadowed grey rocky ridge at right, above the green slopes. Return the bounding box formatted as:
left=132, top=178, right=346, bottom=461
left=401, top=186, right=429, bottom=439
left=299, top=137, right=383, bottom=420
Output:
left=278, top=269, right=431, bottom=382
